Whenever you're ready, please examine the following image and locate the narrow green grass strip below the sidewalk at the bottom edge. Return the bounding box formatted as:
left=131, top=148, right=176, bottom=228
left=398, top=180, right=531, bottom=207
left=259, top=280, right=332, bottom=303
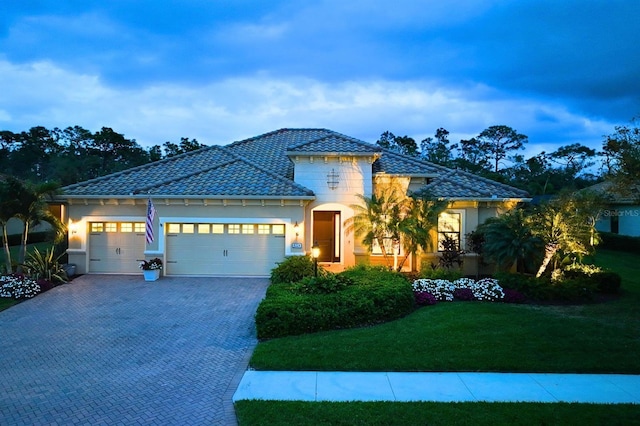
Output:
left=236, top=401, right=640, bottom=426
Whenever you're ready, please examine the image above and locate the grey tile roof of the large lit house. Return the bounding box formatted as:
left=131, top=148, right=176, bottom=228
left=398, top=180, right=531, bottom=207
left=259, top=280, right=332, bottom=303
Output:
left=63, top=129, right=527, bottom=199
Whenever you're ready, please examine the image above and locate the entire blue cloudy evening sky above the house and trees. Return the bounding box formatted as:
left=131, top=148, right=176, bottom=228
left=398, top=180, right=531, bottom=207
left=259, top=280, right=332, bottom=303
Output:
left=0, top=0, right=640, bottom=155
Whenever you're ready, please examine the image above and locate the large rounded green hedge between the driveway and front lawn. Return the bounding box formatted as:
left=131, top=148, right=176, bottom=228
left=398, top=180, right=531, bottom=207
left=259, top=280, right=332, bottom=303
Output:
left=256, top=266, right=414, bottom=339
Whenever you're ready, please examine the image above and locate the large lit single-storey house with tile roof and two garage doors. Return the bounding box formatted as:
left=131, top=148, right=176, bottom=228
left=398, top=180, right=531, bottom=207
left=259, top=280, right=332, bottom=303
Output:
left=59, top=129, right=529, bottom=276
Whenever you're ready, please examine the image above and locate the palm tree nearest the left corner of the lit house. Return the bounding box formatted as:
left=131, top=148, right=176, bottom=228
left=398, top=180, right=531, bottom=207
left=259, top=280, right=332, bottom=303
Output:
left=12, top=181, right=65, bottom=272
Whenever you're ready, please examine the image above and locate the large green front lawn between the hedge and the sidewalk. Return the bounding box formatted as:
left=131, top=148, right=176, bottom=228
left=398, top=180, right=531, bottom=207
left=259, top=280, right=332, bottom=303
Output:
left=251, top=252, right=640, bottom=374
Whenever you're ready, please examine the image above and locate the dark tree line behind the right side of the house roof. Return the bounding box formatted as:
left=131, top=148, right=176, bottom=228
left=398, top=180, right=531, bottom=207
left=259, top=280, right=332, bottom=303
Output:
left=376, top=120, right=640, bottom=195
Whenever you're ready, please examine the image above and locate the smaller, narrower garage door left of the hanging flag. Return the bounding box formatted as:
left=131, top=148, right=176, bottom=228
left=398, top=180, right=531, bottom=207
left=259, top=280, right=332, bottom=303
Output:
left=89, top=222, right=145, bottom=274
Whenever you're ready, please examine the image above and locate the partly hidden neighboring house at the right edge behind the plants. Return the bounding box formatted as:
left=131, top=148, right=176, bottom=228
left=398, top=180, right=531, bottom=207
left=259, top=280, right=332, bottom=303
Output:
left=586, top=182, right=640, bottom=237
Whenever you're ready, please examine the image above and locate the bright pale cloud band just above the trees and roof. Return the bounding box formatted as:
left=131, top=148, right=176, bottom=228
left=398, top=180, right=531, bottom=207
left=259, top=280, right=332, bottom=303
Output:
left=0, top=61, right=613, bottom=153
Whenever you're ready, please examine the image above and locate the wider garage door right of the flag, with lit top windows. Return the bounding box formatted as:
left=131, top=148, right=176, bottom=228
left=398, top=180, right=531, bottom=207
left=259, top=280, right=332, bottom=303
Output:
left=165, top=223, right=285, bottom=276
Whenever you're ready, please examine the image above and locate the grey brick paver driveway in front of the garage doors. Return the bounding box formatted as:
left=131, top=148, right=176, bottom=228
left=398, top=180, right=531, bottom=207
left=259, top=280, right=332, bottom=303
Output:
left=0, top=275, right=268, bottom=425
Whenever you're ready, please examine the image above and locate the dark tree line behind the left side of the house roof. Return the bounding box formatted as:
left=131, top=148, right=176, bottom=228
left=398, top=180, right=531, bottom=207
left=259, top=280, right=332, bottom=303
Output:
left=0, top=126, right=205, bottom=185
